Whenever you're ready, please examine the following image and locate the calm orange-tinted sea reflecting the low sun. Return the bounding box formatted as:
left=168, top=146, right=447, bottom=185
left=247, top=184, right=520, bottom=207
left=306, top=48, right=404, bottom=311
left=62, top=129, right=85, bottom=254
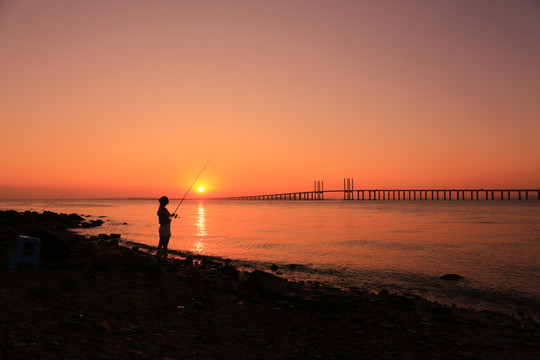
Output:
left=0, top=200, right=540, bottom=319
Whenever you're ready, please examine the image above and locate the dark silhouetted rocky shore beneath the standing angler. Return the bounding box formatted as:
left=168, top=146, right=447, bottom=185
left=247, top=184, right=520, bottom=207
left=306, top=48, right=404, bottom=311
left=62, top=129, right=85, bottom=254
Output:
left=0, top=211, right=540, bottom=360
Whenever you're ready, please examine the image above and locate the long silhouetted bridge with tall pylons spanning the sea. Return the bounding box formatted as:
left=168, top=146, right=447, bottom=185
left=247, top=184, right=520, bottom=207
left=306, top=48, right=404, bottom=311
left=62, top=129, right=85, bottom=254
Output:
left=220, top=179, right=540, bottom=200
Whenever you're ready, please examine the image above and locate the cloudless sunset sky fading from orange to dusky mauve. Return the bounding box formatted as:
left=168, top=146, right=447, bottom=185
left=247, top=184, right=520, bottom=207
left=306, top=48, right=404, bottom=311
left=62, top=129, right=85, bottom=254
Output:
left=0, top=0, right=540, bottom=198
